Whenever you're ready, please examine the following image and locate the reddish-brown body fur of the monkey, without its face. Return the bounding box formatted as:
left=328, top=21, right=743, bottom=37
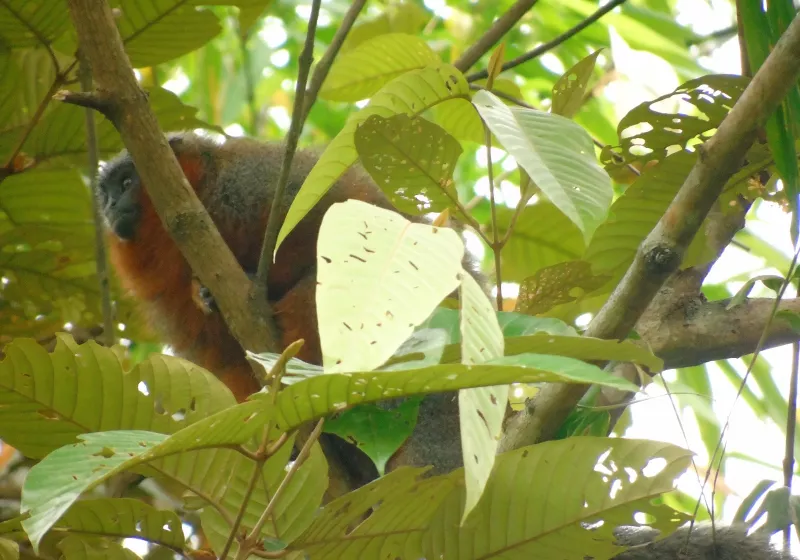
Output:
left=101, top=135, right=398, bottom=401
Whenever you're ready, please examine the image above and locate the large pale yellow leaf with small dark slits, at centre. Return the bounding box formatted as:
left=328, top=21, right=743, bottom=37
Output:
left=317, top=200, right=464, bottom=373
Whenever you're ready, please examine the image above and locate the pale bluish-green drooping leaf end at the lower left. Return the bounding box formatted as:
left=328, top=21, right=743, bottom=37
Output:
left=20, top=430, right=167, bottom=551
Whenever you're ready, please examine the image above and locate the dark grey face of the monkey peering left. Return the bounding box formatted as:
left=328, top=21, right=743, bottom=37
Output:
left=97, top=157, right=142, bottom=241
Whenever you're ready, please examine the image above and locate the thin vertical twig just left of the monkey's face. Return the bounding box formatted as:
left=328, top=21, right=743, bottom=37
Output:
left=78, top=53, right=115, bottom=348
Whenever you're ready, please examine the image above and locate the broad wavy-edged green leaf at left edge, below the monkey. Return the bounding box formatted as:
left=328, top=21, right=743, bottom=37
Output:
left=0, top=335, right=235, bottom=458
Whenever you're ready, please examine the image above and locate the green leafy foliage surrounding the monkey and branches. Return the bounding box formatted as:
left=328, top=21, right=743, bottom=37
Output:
left=0, top=0, right=800, bottom=560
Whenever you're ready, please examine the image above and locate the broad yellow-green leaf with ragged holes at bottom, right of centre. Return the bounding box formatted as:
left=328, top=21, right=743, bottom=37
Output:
left=422, top=437, right=691, bottom=560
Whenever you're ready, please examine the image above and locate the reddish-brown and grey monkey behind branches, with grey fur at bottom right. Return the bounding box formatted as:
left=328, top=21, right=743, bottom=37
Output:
left=100, top=133, right=789, bottom=560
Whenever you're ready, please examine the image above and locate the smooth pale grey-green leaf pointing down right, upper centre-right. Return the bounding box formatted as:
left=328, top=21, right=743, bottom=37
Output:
left=472, top=91, right=613, bottom=242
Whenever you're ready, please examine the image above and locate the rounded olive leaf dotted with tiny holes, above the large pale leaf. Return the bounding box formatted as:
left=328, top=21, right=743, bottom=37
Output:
left=354, top=114, right=462, bottom=214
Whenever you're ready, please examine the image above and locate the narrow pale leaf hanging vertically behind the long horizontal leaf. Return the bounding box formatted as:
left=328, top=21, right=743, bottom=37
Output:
left=458, top=275, right=508, bottom=521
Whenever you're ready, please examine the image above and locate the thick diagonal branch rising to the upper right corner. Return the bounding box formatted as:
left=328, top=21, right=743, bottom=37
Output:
left=500, top=10, right=800, bottom=450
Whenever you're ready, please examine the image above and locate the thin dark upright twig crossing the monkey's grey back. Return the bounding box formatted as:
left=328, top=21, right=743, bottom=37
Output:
left=256, top=0, right=321, bottom=288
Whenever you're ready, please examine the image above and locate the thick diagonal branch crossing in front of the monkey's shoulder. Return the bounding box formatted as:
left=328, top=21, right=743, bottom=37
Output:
left=68, top=0, right=278, bottom=360
